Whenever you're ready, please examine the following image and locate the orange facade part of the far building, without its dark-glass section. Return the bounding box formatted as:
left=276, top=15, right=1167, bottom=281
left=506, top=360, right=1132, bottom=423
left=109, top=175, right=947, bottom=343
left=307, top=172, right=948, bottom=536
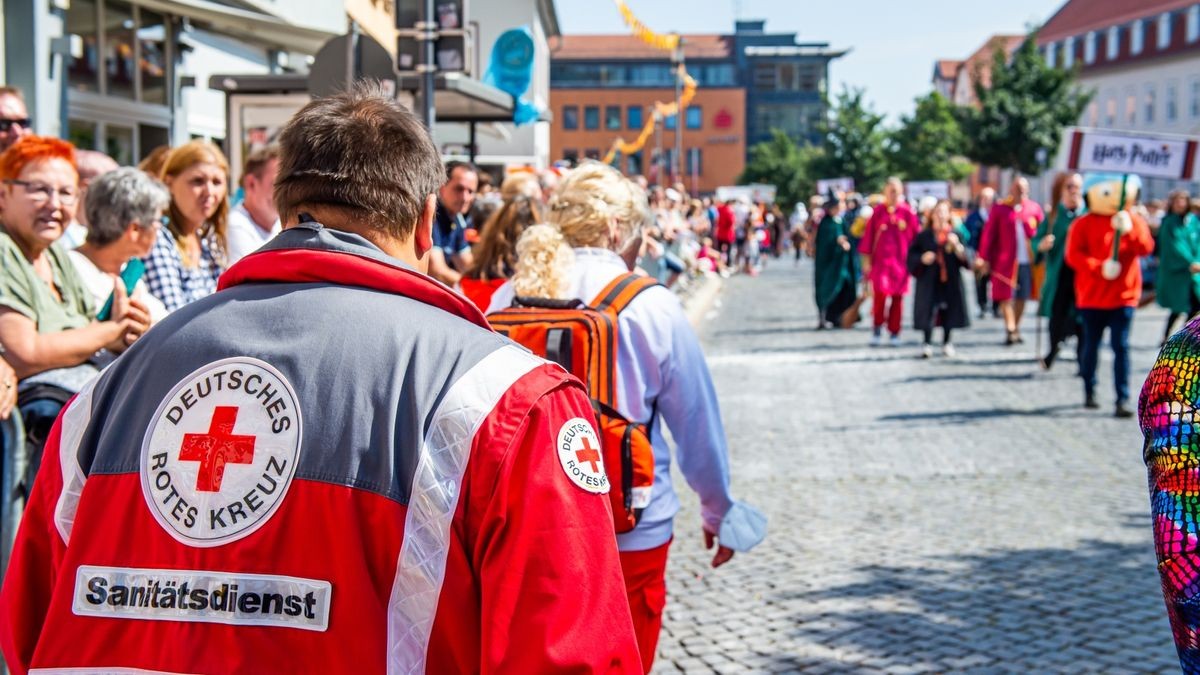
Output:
left=550, top=88, right=746, bottom=195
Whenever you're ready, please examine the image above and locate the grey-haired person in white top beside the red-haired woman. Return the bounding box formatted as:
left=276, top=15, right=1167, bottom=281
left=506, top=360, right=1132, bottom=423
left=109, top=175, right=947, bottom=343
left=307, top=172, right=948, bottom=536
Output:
left=68, top=167, right=170, bottom=323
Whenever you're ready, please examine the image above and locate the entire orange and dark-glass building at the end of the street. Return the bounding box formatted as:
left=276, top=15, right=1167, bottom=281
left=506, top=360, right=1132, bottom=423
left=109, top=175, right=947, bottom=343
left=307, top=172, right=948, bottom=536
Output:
left=550, top=20, right=846, bottom=192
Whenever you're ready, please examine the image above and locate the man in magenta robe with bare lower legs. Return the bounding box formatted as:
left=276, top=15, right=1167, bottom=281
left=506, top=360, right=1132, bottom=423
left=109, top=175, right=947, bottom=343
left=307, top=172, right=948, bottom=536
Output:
left=977, top=177, right=1045, bottom=345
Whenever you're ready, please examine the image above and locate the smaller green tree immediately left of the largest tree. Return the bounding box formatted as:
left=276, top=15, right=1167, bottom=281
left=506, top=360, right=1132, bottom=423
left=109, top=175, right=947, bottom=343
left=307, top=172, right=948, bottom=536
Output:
left=888, top=91, right=972, bottom=181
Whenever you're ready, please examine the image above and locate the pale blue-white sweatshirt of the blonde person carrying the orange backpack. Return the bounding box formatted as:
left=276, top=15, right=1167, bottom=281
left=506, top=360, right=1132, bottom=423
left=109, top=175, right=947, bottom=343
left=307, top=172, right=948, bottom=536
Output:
left=488, top=249, right=734, bottom=551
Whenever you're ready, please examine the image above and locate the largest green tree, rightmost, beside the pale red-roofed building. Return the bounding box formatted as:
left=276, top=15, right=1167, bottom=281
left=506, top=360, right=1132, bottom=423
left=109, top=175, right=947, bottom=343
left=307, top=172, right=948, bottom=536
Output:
left=962, top=31, right=1092, bottom=174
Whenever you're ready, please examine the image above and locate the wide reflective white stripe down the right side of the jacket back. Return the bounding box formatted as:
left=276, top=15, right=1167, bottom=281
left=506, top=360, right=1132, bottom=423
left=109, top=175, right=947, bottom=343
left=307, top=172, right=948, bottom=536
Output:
left=388, top=346, right=545, bottom=675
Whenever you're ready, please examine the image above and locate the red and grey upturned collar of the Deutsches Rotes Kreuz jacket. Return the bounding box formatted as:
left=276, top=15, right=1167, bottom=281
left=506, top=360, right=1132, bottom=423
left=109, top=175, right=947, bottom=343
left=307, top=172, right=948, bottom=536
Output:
left=217, top=222, right=491, bottom=330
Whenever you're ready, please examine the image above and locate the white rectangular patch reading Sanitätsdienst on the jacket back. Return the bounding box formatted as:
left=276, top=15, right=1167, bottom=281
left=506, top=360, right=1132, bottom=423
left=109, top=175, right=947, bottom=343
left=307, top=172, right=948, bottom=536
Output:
left=71, top=565, right=332, bottom=632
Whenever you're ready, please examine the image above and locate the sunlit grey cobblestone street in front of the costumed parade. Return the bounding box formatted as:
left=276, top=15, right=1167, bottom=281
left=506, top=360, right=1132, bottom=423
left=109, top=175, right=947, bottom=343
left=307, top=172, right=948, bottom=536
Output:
left=655, top=259, right=1178, bottom=673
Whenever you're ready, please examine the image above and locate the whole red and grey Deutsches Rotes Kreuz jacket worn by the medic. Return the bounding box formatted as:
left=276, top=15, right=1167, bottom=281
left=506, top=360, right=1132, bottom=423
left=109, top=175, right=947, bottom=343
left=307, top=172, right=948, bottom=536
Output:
left=0, top=225, right=641, bottom=674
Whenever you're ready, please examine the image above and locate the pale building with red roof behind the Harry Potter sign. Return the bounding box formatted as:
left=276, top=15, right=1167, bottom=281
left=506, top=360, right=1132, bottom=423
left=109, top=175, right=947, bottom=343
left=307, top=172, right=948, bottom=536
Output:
left=1038, top=0, right=1200, bottom=197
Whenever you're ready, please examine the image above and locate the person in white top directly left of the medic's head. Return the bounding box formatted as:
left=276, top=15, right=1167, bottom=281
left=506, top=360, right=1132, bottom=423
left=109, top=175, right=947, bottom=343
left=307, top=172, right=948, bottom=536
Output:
left=227, top=145, right=280, bottom=264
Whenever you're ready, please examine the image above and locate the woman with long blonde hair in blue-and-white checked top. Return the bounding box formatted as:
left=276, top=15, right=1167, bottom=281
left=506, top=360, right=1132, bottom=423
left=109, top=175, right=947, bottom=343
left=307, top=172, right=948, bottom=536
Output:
left=145, top=141, right=229, bottom=311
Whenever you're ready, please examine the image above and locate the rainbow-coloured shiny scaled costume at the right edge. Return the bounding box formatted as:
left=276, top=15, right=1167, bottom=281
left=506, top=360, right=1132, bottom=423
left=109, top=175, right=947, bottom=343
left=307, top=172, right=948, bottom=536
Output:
left=1139, top=319, right=1200, bottom=673
